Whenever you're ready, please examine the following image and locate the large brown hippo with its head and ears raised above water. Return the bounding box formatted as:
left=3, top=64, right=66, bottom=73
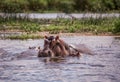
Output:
left=38, top=36, right=80, bottom=57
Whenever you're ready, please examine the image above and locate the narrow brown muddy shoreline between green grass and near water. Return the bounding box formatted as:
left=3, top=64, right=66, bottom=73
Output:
left=0, top=31, right=120, bottom=40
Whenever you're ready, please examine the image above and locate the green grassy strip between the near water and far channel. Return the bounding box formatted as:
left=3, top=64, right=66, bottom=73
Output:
left=0, top=17, right=120, bottom=39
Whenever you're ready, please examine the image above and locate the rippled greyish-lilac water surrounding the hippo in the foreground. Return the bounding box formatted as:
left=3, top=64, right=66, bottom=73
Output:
left=0, top=36, right=120, bottom=82
